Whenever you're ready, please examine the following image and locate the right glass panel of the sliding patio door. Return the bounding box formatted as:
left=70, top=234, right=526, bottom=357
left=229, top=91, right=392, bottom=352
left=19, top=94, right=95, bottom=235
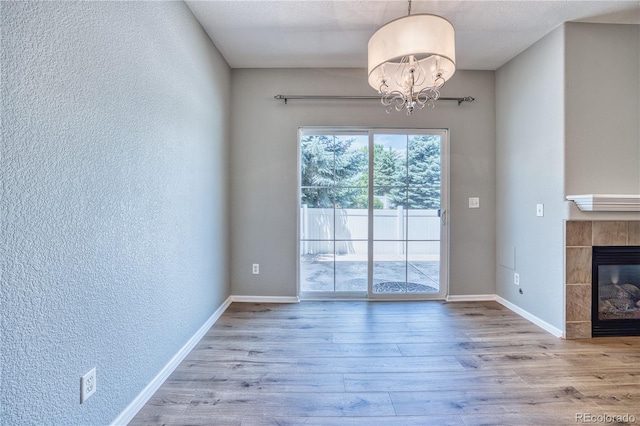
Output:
left=371, top=133, right=442, bottom=296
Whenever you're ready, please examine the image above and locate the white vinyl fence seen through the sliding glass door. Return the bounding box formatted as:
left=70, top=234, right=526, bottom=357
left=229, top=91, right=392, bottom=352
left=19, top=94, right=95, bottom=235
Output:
left=300, top=204, right=440, bottom=255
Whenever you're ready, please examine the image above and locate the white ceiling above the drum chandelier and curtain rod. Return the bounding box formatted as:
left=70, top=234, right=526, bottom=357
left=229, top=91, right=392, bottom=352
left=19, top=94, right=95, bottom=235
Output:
left=187, top=0, right=640, bottom=70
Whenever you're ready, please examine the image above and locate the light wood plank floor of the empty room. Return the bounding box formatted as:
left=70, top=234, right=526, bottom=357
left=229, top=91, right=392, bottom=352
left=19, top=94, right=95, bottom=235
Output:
left=130, top=302, right=640, bottom=426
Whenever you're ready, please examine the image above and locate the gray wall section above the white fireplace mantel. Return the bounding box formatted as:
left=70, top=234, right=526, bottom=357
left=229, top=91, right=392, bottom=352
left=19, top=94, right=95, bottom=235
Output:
left=565, top=23, right=640, bottom=220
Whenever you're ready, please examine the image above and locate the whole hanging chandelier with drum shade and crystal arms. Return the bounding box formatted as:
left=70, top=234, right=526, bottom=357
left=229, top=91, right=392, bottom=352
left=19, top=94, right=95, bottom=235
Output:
left=368, top=0, right=456, bottom=115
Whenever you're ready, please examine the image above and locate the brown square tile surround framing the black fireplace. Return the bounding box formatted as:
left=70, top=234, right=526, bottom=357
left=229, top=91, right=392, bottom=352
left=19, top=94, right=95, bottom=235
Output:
left=565, top=220, right=640, bottom=339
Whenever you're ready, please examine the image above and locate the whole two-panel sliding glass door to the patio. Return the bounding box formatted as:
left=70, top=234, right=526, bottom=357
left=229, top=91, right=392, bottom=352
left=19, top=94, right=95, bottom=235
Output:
left=298, top=128, right=447, bottom=299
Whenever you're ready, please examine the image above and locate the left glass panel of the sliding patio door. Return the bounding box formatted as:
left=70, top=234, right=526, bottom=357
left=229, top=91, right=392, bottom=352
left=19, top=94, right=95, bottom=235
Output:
left=299, top=130, right=369, bottom=294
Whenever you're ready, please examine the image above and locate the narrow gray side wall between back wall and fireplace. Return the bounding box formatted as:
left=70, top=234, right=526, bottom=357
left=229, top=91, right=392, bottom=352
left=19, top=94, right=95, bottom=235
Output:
left=496, top=28, right=564, bottom=329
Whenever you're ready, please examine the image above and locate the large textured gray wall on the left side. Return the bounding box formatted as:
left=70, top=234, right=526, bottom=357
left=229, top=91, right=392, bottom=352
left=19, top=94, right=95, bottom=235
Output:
left=0, top=2, right=230, bottom=425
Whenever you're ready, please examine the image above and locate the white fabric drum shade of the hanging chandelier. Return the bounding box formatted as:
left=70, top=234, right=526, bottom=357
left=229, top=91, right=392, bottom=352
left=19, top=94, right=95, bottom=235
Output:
left=368, top=14, right=456, bottom=91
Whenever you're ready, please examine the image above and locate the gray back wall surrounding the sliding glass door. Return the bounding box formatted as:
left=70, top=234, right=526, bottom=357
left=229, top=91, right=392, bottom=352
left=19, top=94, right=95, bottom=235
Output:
left=230, top=69, right=495, bottom=296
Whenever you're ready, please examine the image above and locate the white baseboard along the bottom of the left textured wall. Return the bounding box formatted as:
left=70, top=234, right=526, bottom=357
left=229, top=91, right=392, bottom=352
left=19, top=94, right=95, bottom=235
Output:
left=111, top=296, right=232, bottom=426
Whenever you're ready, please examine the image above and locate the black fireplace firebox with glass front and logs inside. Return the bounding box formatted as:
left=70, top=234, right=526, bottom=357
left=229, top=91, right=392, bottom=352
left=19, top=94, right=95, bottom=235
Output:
left=591, top=246, right=640, bottom=337
